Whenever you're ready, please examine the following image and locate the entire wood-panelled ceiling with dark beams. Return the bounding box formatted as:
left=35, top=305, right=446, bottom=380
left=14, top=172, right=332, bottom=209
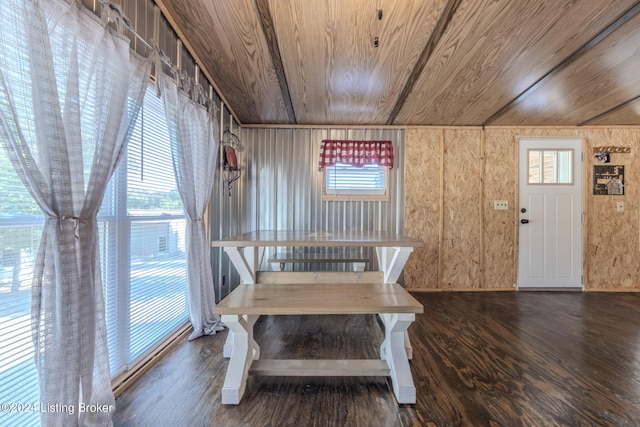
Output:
left=156, top=0, right=640, bottom=126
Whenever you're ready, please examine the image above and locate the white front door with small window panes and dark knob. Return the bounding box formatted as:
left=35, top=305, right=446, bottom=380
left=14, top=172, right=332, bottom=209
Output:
left=518, top=138, right=583, bottom=289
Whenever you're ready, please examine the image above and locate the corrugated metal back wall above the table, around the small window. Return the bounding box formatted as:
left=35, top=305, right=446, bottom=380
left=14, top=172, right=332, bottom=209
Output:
left=242, top=128, right=404, bottom=231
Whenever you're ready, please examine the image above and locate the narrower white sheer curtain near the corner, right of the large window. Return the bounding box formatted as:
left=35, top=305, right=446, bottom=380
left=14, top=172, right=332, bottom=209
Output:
left=161, top=72, right=224, bottom=339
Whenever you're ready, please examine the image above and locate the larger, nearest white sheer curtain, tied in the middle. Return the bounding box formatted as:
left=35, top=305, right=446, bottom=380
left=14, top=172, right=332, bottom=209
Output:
left=0, top=0, right=150, bottom=426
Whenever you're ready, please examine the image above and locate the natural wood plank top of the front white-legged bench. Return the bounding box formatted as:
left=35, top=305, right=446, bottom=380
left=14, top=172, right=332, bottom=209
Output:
left=214, top=283, right=424, bottom=315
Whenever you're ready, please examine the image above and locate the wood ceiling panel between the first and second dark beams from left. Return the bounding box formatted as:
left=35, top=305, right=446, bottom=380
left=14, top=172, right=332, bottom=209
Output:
left=269, top=0, right=446, bottom=125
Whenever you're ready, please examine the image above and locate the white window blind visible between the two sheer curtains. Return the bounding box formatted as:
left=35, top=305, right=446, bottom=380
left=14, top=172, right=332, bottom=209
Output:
left=100, top=87, right=188, bottom=375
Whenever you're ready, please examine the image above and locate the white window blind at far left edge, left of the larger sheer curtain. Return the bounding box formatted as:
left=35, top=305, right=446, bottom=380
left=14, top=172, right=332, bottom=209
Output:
left=0, top=147, right=44, bottom=426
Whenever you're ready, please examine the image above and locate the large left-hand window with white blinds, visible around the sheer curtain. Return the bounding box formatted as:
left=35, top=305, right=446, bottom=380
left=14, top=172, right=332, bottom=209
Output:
left=0, top=84, right=188, bottom=426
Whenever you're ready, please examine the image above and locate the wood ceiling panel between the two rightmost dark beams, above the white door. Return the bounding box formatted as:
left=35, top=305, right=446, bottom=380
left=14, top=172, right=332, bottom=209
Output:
left=491, top=10, right=640, bottom=126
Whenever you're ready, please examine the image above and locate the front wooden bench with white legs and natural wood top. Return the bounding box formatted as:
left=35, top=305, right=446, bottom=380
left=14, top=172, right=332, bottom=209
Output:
left=214, top=272, right=423, bottom=404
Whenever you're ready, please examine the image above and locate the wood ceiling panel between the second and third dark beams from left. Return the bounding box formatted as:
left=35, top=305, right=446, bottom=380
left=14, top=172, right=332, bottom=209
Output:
left=395, top=0, right=635, bottom=125
